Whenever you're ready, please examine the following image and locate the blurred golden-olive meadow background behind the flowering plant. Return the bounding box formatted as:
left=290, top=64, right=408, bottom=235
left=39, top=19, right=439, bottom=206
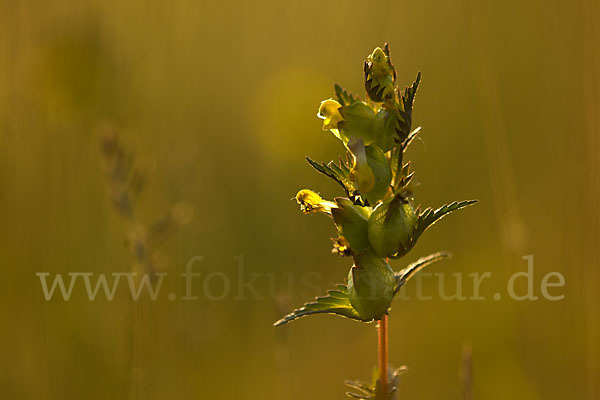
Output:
left=0, top=0, right=600, bottom=400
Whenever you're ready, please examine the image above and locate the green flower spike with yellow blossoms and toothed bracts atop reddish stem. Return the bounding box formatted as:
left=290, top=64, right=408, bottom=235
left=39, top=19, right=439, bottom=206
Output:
left=276, top=45, right=475, bottom=325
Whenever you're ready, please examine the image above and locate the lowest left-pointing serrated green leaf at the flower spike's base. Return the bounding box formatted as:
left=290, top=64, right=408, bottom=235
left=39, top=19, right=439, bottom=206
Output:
left=275, top=284, right=366, bottom=326
